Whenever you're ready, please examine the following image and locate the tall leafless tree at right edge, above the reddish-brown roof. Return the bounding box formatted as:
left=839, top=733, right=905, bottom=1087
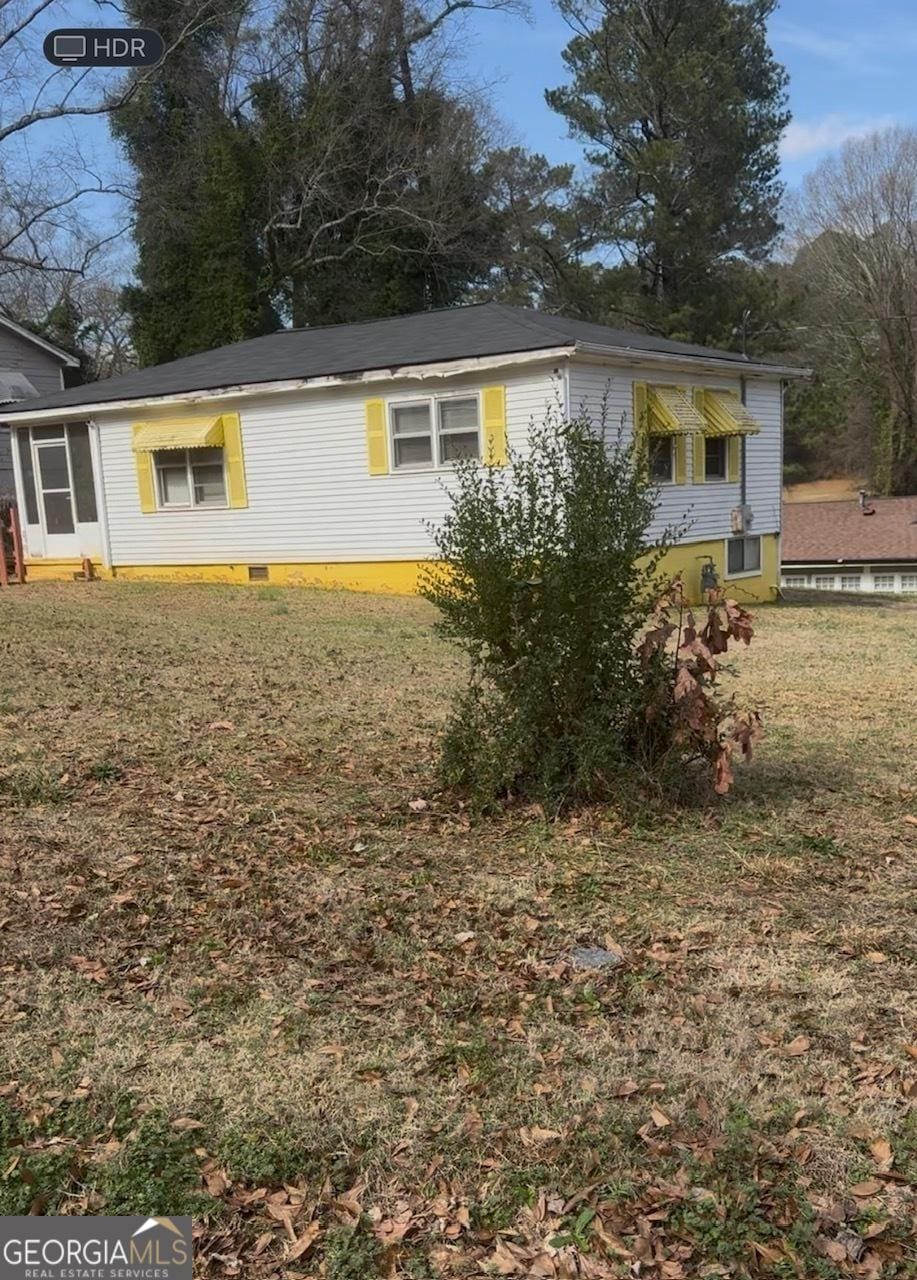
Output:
left=795, top=128, right=917, bottom=494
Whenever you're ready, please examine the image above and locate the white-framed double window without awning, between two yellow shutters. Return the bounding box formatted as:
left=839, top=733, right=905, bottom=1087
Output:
left=388, top=394, right=480, bottom=471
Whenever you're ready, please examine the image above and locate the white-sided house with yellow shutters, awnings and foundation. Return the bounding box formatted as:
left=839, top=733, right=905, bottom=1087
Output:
left=5, top=302, right=802, bottom=599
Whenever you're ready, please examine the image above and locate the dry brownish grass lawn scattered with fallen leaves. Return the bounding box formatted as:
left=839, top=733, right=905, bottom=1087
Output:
left=0, top=584, right=917, bottom=1280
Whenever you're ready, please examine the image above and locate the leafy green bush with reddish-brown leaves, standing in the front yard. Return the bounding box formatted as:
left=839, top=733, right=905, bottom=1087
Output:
left=420, top=413, right=753, bottom=812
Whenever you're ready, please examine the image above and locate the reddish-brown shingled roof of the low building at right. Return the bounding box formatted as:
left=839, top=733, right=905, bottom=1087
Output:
left=781, top=495, right=917, bottom=564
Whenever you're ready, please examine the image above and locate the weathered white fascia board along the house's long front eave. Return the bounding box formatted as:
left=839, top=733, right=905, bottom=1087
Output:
left=0, top=346, right=572, bottom=426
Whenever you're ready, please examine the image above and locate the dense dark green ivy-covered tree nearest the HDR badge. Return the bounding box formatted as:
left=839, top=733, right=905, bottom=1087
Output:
left=113, top=0, right=278, bottom=365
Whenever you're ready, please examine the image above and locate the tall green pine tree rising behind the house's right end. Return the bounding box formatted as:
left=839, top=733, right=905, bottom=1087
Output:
left=547, top=0, right=789, bottom=342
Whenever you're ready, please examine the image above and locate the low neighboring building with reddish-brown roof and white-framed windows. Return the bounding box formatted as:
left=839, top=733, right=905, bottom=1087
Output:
left=780, top=493, right=917, bottom=595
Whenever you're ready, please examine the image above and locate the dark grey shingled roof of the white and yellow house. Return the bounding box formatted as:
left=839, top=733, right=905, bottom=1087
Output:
left=0, top=302, right=788, bottom=412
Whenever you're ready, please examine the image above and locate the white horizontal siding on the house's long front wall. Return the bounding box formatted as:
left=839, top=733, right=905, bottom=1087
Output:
left=97, top=364, right=562, bottom=564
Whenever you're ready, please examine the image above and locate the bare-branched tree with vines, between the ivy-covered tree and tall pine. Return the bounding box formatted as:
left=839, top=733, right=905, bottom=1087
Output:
left=252, top=0, right=525, bottom=324
